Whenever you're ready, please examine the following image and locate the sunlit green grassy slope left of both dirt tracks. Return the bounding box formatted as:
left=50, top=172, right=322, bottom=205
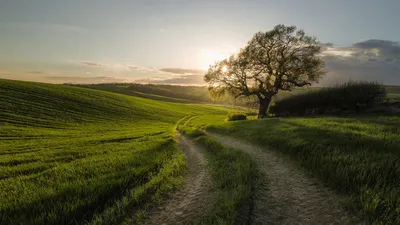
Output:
left=0, top=80, right=230, bottom=224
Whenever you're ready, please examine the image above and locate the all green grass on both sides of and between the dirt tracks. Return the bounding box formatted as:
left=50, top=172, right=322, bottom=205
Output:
left=0, top=80, right=400, bottom=224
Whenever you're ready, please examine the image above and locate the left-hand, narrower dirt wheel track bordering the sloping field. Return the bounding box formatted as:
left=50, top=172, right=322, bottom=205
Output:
left=146, top=135, right=212, bottom=225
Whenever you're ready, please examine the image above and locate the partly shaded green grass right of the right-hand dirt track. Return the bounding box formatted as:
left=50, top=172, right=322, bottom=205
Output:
left=205, top=115, right=400, bottom=224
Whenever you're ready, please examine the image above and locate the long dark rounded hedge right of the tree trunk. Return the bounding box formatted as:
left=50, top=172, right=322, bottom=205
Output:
left=269, top=81, right=387, bottom=116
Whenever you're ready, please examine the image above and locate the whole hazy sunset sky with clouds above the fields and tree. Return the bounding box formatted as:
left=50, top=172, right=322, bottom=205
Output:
left=0, top=0, right=400, bottom=85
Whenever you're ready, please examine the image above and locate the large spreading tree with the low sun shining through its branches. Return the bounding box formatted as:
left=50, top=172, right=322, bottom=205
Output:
left=204, top=25, right=325, bottom=118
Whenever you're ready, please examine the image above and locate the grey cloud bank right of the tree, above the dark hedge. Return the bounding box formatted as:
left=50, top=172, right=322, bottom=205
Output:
left=321, top=39, right=400, bottom=85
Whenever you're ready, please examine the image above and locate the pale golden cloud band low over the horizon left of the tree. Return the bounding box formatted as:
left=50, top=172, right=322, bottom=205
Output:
left=0, top=61, right=206, bottom=85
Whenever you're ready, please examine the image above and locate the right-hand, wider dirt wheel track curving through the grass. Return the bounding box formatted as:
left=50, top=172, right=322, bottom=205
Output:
left=208, top=133, right=357, bottom=224
